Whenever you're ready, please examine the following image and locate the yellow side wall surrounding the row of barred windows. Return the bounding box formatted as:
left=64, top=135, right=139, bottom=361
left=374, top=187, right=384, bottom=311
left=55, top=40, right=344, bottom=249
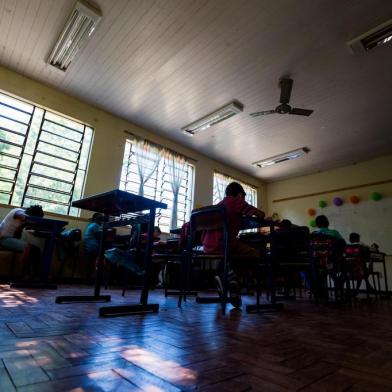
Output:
left=0, top=67, right=267, bottom=224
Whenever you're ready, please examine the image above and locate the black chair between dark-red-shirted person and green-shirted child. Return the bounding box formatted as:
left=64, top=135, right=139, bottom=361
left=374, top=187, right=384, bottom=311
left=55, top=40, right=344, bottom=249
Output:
left=271, top=227, right=312, bottom=299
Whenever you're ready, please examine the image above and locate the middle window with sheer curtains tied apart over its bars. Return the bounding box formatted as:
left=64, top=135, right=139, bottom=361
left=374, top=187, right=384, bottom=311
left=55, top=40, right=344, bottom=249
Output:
left=120, top=140, right=194, bottom=233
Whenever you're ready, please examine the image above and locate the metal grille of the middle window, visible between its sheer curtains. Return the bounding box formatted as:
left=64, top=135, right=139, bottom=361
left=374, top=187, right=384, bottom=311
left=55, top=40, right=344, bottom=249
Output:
left=120, top=140, right=194, bottom=232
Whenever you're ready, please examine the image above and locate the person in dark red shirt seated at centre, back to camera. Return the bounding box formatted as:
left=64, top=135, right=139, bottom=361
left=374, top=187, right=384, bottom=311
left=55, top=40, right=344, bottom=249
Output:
left=202, top=182, right=265, bottom=307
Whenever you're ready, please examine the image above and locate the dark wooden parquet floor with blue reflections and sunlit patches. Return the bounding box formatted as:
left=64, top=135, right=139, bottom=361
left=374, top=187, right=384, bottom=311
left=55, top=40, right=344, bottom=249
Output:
left=0, top=286, right=392, bottom=392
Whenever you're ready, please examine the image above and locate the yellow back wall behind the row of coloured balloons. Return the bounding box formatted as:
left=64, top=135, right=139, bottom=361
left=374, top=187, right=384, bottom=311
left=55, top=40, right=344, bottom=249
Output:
left=268, top=155, right=392, bottom=253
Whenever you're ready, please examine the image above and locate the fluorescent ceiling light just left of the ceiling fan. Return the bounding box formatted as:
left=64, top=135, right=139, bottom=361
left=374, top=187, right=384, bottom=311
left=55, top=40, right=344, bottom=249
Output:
left=181, top=101, right=244, bottom=136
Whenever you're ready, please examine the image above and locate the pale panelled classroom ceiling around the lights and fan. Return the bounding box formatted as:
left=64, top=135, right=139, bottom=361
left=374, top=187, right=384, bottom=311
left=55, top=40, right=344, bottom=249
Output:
left=0, top=0, right=392, bottom=181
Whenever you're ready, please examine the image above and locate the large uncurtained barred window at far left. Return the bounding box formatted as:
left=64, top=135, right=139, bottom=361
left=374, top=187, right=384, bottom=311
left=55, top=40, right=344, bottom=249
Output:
left=0, top=93, right=93, bottom=216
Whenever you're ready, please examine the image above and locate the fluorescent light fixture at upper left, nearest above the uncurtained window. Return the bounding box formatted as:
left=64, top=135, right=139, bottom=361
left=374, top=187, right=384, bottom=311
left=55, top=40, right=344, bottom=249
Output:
left=48, top=0, right=102, bottom=72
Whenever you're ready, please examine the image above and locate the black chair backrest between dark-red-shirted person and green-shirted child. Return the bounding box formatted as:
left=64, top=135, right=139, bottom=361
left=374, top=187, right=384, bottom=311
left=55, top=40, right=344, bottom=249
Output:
left=271, top=226, right=310, bottom=263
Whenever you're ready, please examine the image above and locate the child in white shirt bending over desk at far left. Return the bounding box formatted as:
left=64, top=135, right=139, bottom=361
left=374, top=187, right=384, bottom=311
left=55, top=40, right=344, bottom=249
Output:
left=0, top=205, right=44, bottom=275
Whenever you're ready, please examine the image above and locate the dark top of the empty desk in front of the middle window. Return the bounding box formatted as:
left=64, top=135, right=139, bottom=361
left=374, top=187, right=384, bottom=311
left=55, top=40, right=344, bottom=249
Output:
left=72, top=189, right=167, bottom=215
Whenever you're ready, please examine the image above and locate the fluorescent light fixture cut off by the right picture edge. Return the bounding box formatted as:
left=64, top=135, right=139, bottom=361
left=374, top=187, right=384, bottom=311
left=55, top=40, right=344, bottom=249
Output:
left=348, top=19, right=392, bottom=54
